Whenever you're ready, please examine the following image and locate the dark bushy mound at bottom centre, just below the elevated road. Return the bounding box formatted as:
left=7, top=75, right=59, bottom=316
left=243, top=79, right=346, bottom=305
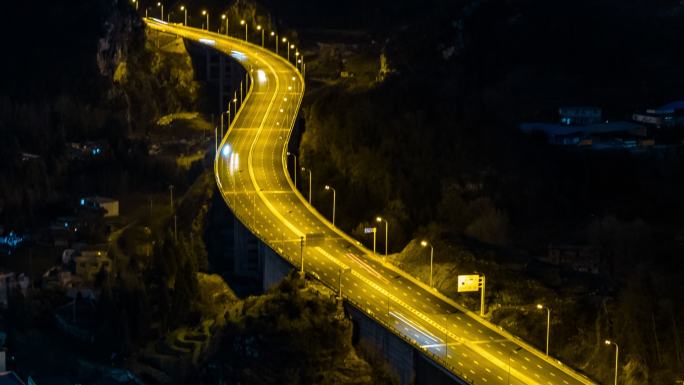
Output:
left=202, top=273, right=397, bottom=385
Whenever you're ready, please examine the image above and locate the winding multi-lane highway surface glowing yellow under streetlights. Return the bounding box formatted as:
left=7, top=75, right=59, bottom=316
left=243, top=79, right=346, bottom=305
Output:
left=146, top=19, right=593, bottom=385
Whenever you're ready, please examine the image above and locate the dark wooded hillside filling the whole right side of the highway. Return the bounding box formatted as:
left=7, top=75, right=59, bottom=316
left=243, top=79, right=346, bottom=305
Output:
left=300, top=0, right=684, bottom=384
